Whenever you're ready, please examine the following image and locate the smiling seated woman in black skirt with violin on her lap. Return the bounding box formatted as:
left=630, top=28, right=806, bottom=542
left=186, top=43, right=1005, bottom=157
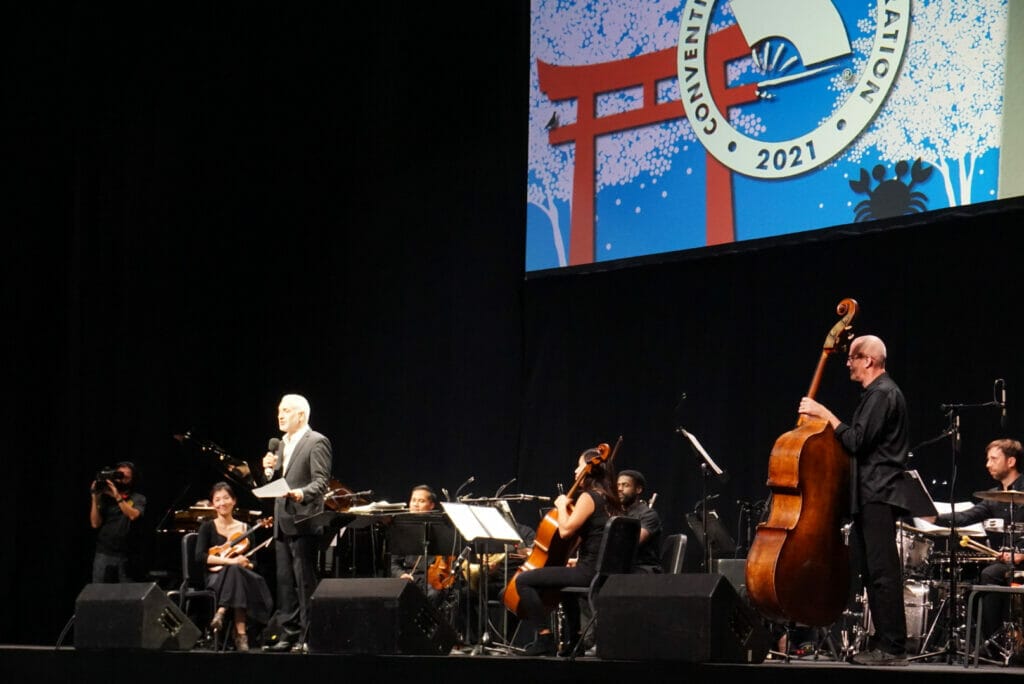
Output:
left=196, top=482, right=273, bottom=651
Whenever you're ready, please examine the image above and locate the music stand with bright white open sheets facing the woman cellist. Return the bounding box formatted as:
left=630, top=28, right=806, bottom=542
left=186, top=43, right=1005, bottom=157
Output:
left=441, top=502, right=522, bottom=655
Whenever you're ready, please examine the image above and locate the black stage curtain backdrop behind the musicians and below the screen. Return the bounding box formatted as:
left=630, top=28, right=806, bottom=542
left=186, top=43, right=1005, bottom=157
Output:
left=8, top=2, right=1024, bottom=644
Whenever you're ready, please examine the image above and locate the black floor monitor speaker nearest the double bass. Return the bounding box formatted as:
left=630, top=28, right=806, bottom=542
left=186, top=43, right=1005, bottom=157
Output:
left=596, top=573, right=771, bottom=662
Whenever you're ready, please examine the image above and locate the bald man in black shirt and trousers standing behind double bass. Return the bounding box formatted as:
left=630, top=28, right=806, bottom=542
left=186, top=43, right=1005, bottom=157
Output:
left=799, top=335, right=909, bottom=666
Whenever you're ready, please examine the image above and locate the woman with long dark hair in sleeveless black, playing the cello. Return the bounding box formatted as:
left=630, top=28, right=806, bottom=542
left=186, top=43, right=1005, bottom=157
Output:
left=507, top=450, right=623, bottom=655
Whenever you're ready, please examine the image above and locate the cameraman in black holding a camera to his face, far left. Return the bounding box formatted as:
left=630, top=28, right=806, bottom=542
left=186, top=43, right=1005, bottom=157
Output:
left=89, top=461, right=145, bottom=583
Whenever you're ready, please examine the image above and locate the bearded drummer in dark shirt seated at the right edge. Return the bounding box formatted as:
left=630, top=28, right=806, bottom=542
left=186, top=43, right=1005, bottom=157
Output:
left=925, top=439, right=1024, bottom=639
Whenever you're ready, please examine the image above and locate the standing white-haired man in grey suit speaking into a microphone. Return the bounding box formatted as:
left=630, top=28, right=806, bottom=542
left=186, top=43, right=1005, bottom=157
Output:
left=263, top=394, right=331, bottom=651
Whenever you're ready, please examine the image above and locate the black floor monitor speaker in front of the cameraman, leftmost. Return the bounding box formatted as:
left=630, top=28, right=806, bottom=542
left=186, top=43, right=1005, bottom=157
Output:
left=74, top=582, right=202, bottom=650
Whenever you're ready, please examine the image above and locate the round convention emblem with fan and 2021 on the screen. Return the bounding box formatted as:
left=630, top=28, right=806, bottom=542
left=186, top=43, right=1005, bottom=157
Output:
left=677, top=0, right=910, bottom=178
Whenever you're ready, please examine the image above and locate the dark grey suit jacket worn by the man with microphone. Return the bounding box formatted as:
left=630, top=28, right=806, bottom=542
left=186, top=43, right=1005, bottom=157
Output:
left=270, top=430, right=331, bottom=539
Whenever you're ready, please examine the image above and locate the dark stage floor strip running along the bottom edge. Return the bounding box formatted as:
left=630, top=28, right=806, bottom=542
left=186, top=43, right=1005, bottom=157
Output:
left=0, top=645, right=1024, bottom=684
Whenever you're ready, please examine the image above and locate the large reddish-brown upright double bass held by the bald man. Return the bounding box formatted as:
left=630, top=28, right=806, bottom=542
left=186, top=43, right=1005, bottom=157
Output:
left=746, top=299, right=857, bottom=627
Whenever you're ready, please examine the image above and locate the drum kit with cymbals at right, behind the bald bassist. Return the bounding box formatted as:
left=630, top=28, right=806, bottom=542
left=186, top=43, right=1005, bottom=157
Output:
left=841, top=490, right=1024, bottom=660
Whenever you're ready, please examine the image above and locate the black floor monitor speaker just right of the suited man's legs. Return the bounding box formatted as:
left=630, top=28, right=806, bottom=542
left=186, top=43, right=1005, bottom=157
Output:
left=306, top=578, right=458, bottom=655
